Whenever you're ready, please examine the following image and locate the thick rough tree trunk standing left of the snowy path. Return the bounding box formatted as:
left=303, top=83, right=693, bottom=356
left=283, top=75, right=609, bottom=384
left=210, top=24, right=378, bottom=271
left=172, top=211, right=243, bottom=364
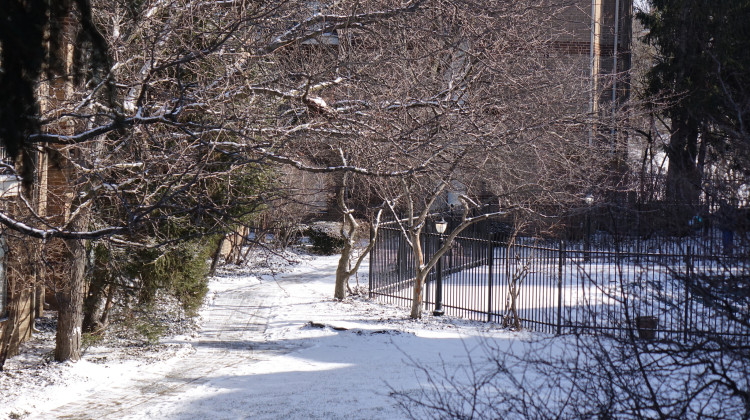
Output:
left=55, top=215, right=87, bottom=362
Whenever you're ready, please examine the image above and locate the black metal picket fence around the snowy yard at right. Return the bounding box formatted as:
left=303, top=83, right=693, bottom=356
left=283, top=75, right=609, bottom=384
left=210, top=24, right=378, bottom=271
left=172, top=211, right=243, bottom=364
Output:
left=369, top=226, right=750, bottom=340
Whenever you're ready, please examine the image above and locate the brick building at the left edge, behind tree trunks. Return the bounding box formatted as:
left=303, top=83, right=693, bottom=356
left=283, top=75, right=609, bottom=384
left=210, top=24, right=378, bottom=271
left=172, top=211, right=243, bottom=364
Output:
left=0, top=13, right=73, bottom=366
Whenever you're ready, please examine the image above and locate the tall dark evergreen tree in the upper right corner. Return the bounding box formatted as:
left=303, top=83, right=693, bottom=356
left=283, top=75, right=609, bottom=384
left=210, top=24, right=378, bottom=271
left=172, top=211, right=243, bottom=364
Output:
left=637, top=0, right=750, bottom=209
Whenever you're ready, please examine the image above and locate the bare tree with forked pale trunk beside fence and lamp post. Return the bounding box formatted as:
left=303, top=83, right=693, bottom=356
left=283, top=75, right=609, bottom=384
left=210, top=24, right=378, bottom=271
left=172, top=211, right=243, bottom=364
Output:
left=362, top=2, right=607, bottom=318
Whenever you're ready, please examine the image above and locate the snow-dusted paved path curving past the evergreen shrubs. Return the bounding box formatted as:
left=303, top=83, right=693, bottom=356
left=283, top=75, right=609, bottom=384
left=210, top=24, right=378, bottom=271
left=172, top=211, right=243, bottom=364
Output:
left=46, top=264, right=296, bottom=420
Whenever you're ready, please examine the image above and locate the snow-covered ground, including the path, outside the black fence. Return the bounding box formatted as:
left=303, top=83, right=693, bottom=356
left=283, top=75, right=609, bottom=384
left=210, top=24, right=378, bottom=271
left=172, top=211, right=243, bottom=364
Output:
left=0, top=251, right=540, bottom=419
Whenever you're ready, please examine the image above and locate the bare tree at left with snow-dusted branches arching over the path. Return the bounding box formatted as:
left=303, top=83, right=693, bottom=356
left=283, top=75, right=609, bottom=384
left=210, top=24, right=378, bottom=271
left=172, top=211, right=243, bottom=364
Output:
left=0, top=0, right=434, bottom=360
